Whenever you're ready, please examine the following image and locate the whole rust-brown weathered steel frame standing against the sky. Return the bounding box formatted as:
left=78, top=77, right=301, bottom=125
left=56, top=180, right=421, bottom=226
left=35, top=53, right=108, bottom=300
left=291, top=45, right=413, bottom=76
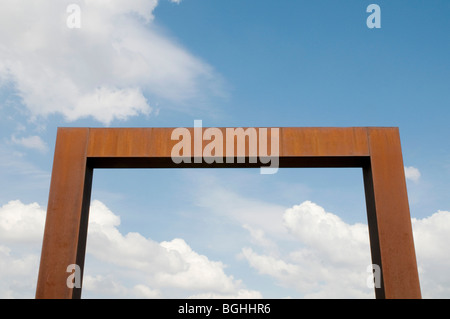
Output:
left=36, top=127, right=421, bottom=298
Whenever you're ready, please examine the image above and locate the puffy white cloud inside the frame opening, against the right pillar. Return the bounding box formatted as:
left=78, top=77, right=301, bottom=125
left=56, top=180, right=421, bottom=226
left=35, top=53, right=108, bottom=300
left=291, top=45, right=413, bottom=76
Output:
left=242, top=201, right=373, bottom=298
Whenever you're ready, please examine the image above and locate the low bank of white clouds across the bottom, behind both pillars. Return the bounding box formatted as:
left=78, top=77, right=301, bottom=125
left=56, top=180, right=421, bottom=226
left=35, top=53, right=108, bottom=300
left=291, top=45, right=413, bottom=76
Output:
left=0, top=201, right=450, bottom=298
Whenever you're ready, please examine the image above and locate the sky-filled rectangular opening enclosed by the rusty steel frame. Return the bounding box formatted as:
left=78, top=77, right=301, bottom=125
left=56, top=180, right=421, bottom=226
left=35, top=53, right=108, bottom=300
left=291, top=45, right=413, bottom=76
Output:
left=83, top=168, right=374, bottom=298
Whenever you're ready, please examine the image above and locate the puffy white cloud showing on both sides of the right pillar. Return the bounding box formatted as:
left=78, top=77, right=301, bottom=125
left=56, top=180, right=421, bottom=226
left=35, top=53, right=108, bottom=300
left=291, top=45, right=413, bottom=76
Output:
left=241, top=201, right=450, bottom=298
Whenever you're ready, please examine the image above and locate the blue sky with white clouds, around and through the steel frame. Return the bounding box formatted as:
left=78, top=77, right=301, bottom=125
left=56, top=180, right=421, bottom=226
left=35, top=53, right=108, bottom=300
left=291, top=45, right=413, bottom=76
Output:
left=0, top=0, right=450, bottom=298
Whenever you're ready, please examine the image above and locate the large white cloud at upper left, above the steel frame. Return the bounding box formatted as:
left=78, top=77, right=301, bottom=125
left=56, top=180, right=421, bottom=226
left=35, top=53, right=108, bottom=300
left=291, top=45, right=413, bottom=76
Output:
left=0, top=0, right=217, bottom=124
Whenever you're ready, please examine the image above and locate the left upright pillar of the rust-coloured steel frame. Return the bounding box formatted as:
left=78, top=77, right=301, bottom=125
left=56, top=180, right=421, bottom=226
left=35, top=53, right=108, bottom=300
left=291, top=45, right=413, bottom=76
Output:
left=36, top=128, right=93, bottom=299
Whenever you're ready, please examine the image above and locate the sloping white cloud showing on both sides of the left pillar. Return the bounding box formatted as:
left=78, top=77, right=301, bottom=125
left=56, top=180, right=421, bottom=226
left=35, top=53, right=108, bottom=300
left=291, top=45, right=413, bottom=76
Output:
left=0, top=200, right=260, bottom=298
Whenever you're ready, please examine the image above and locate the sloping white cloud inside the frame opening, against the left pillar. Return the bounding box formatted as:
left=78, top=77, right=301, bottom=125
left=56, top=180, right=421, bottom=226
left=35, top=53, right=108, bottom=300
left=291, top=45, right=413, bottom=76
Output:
left=85, top=201, right=255, bottom=297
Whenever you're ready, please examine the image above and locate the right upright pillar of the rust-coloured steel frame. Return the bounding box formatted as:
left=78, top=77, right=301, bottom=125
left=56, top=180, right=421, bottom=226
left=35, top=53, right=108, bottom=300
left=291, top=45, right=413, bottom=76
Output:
left=363, top=128, right=421, bottom=299
